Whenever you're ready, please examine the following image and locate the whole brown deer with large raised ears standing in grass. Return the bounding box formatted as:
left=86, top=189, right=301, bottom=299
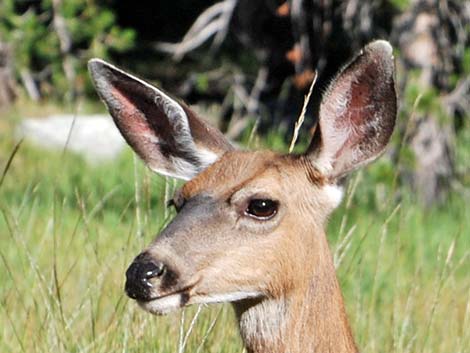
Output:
left=88, top=40, right=397, bottom=353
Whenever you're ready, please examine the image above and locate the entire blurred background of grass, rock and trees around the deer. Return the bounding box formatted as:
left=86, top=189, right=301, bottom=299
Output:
left=0, top=0, right=470, bottom=353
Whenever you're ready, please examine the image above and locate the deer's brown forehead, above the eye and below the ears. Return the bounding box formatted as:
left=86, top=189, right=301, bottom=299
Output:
left=181, top=151, right=341, bottom=211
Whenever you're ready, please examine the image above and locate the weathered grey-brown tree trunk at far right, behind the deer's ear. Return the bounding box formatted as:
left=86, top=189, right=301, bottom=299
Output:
left=394, top=0, right=468, bottom=206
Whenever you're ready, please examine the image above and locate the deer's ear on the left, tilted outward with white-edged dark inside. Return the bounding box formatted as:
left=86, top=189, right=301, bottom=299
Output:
left=88, top=59, right=233, bottom=180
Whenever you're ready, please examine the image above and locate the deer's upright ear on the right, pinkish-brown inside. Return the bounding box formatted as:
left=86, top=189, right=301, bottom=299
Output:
left=307, top=40, right=397, bottom=179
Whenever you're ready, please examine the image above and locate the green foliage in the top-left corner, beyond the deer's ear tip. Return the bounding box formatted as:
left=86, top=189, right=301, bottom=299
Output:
left=0, top=0, right=135, bottom=99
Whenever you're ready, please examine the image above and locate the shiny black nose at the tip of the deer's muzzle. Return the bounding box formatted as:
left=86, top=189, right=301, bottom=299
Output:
left=125, top=254, right=166, bottom=300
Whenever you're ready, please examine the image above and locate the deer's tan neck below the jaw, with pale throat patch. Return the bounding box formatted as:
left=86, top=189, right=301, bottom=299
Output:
left=234, top=228, right=357, bottom=353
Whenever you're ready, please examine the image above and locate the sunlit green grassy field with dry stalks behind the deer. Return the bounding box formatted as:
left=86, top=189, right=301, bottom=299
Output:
left=0, top=102, right=470, bottom=353
